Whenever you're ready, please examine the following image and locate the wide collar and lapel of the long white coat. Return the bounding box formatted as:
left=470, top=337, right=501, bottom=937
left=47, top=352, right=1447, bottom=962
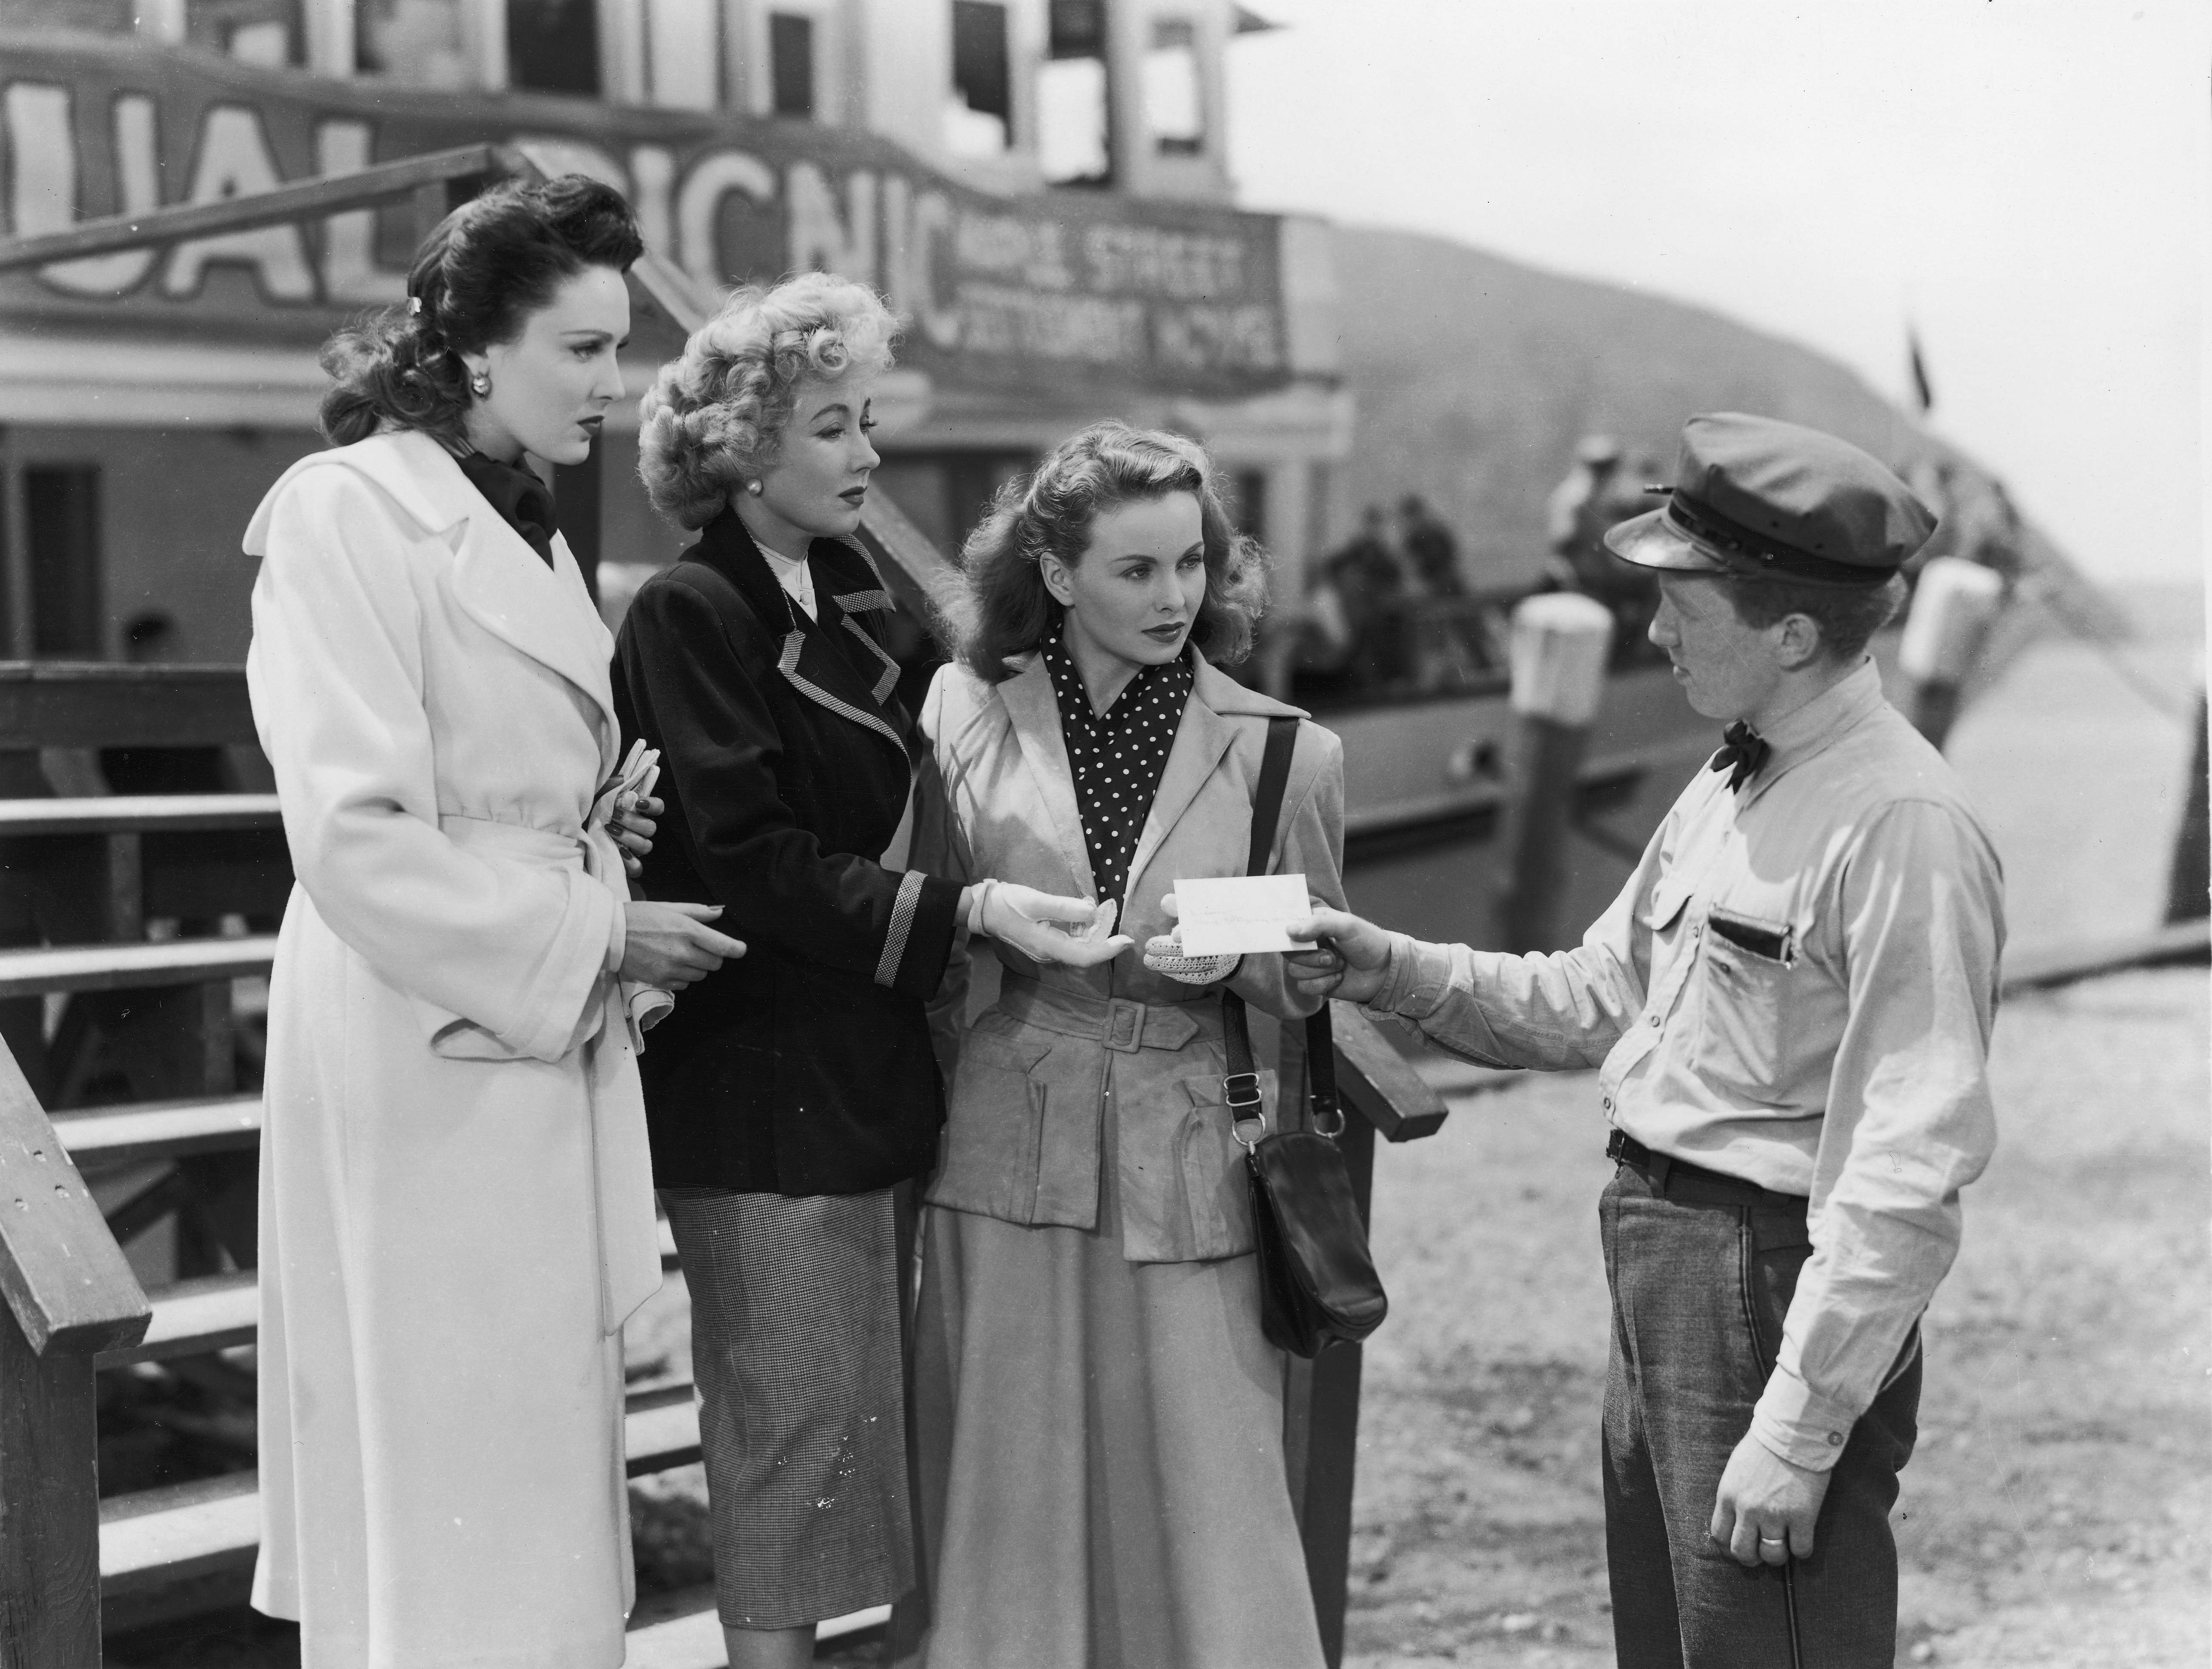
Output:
left=294, top=433, right=617, bottom=756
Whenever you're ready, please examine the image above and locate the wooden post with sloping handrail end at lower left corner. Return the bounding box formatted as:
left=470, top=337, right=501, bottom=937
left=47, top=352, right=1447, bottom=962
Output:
left=0, top=1039, right=151, bottom=1669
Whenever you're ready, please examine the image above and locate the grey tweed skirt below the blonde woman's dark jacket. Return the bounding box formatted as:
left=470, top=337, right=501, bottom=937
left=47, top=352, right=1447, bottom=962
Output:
left=661, top=1189, right=914, bottom=1629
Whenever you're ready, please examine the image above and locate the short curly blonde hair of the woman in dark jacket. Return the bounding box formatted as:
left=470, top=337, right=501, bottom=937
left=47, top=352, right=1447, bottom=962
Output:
left=637, top=272, right=898, bottom=528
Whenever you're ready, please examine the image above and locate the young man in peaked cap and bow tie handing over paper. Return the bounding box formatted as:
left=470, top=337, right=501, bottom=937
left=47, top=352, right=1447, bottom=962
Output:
left=1292, top=413, right=2004, bottom=1669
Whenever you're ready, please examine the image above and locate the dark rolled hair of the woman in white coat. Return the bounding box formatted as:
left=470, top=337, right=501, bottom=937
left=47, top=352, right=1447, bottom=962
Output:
left=321, top=175, right=646, bottom=447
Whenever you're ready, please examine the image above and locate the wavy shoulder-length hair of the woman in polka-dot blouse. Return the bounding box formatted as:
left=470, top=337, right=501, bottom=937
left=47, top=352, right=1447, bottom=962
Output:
left=947, top=422, right=1267, bottom=683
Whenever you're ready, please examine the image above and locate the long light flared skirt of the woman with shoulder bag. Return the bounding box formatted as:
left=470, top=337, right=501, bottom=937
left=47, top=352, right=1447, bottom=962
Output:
left=893, top=1103, right=1323, bottom=1669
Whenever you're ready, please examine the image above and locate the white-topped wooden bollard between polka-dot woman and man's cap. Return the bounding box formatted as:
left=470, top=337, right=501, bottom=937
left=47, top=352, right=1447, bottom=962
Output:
left=1497, top=590, right=1613, bottom=951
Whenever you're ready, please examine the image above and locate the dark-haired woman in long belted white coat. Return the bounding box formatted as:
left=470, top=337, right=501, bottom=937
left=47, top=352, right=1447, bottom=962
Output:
left=246, top=177, right=743, bottom=1669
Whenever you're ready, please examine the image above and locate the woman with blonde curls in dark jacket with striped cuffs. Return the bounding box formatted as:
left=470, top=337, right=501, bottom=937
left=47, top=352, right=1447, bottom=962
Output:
left=615, top=274, right=1128, bottom=1669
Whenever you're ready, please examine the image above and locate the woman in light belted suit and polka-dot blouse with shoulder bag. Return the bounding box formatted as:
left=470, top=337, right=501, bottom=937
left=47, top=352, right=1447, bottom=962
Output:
left=898, top=425, right=1343, bottom=1669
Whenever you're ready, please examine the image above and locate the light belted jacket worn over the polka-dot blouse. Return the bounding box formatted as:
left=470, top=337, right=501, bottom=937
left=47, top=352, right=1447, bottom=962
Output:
left=914, top=656, right=1345, bottom=1262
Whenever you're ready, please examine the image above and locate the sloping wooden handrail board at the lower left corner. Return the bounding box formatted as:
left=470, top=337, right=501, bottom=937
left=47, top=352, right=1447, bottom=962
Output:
left=0, top=1050, right=151, bottom=1355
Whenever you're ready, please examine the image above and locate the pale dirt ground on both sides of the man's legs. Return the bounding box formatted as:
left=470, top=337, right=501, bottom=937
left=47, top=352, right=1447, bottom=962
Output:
left=1347, top=968, right=2212, bottom=1669
